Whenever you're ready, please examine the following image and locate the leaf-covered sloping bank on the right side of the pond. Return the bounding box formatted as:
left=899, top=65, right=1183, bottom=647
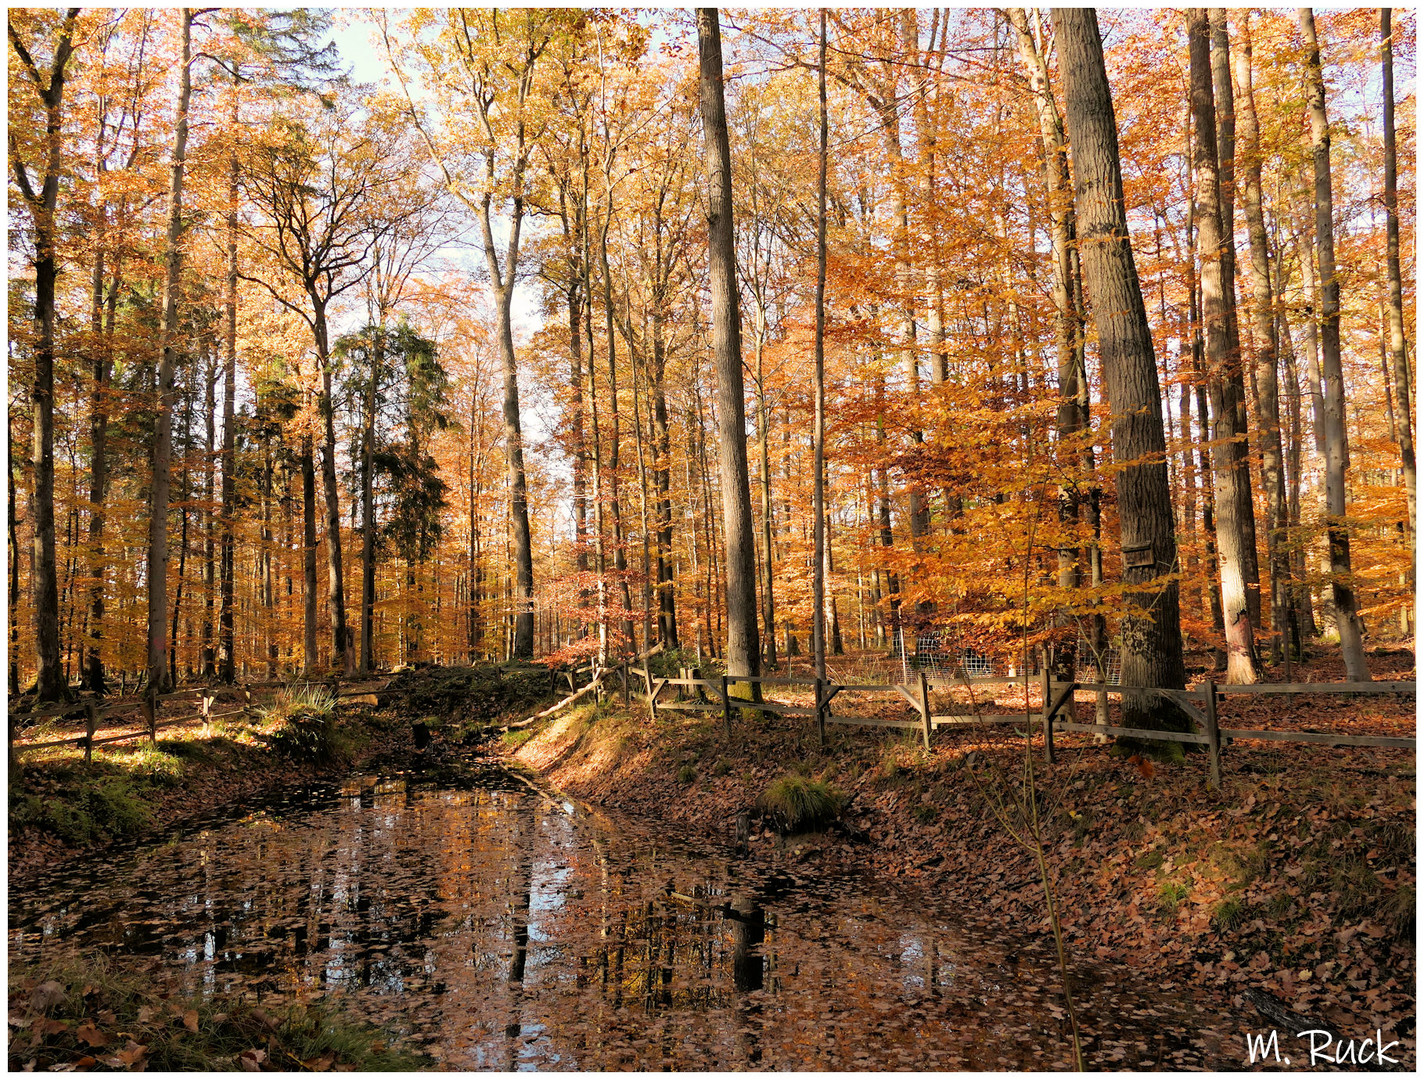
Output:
left=503, top=651, right=1417, bottom=1061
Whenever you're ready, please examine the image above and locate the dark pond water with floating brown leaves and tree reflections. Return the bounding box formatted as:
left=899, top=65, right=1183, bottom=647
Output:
left=10, top=769, right=1236, bottom=1070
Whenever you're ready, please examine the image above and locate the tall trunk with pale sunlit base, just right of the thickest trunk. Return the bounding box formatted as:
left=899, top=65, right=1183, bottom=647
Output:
left=1186, top=7, right=1260, bottom=682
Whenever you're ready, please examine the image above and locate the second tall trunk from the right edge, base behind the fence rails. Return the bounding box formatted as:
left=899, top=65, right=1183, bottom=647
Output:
left=1300, top=7, right=1370, bottom=682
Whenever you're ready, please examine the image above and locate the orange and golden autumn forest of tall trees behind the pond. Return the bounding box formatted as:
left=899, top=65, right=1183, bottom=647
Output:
left=7, top=9, right=1415, bottom=715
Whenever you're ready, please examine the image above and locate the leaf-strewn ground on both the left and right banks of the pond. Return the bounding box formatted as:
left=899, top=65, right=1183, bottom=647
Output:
left=9, top=651, right=1417, bottom=1061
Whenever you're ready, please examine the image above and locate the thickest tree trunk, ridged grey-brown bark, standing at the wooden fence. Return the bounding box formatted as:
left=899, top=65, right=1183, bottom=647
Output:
left=1052, top=9, right=1189, bottom=731
